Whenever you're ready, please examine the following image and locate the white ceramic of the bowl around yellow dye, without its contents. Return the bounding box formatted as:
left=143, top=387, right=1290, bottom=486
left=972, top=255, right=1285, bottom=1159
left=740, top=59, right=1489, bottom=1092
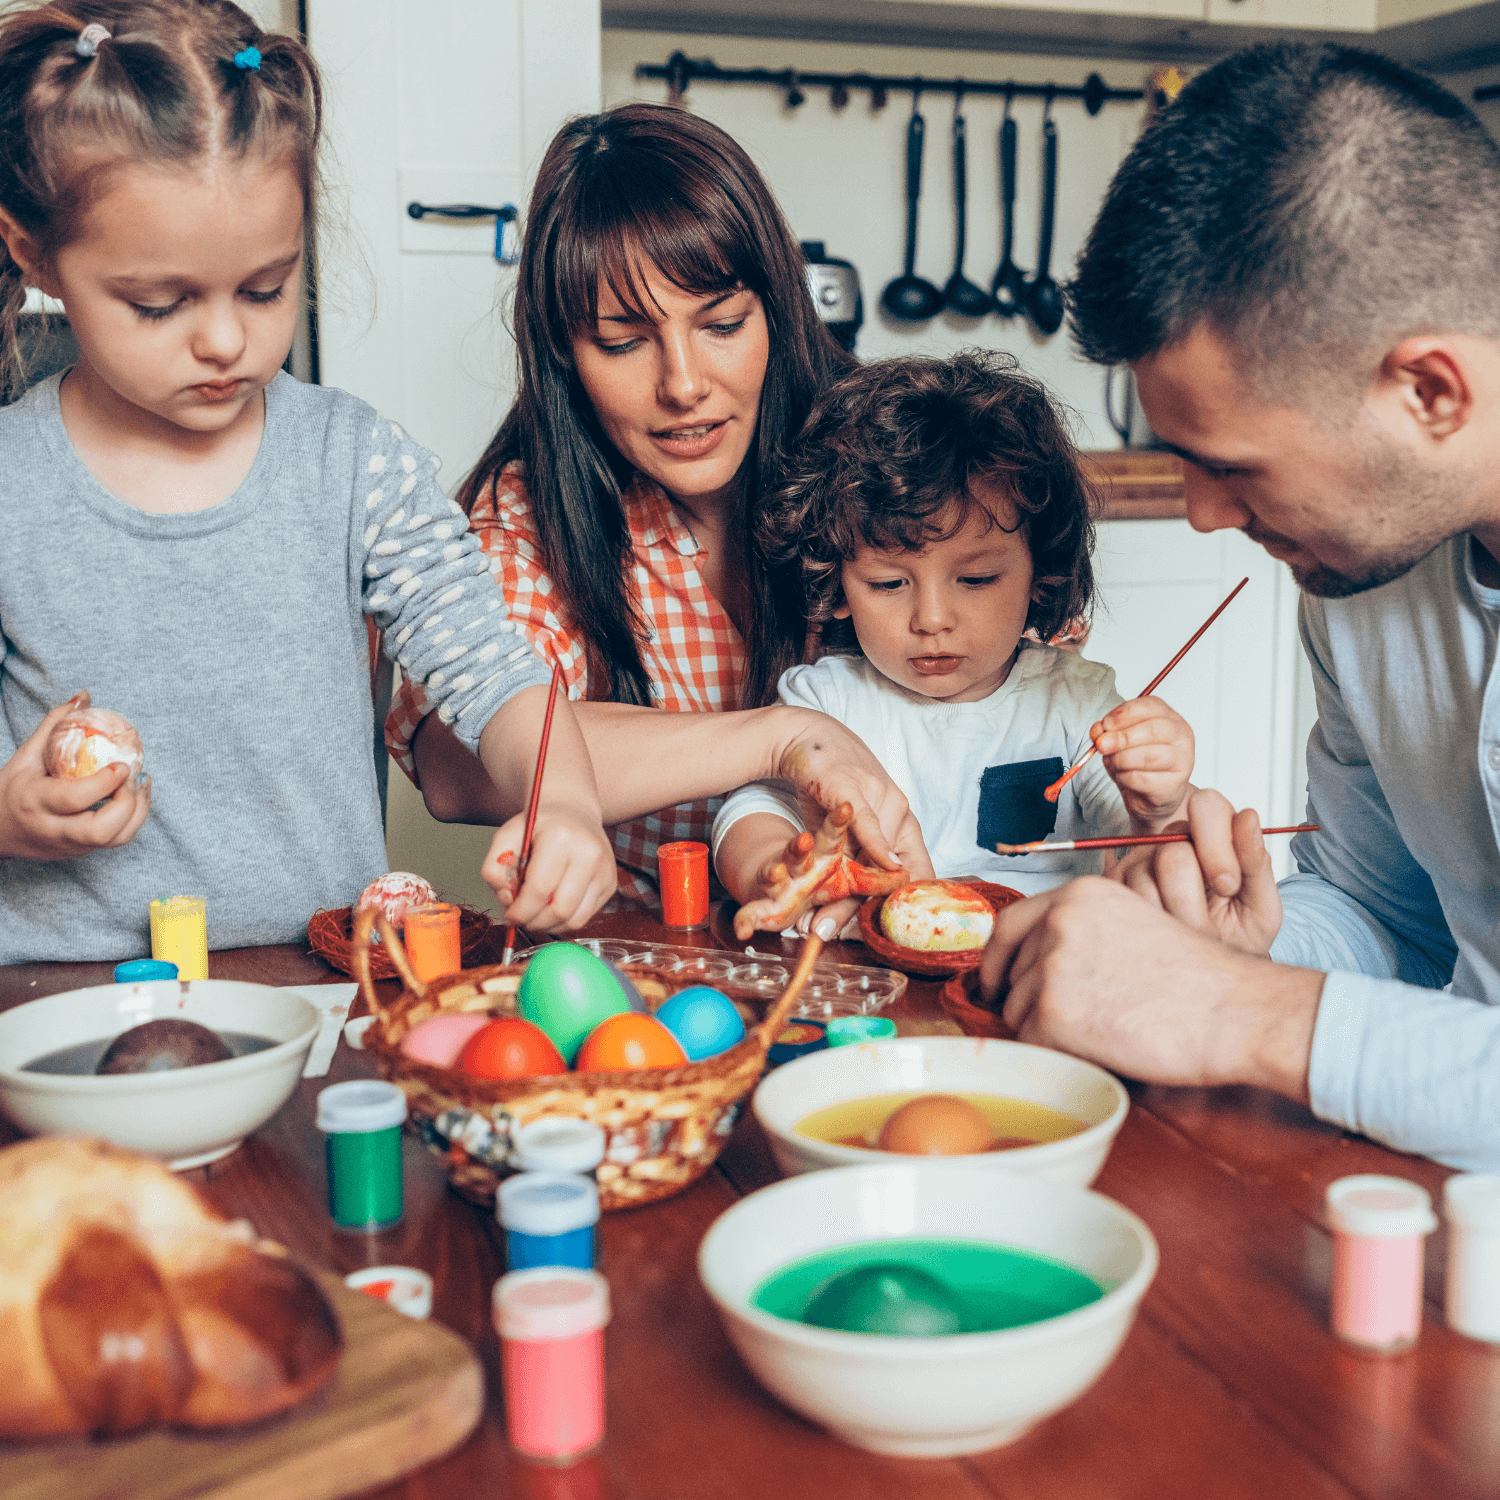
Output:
left=753, top=1037, right=1130, bottom=1187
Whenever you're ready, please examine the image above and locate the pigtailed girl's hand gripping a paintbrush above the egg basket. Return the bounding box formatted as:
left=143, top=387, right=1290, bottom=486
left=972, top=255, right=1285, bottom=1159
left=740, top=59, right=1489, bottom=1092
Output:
left=480, top=797, right=617, bottom=933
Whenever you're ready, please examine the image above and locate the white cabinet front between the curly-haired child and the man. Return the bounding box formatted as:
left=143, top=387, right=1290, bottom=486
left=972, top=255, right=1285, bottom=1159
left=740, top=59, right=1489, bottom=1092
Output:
left=1083, top=521, right=1311, bottom=876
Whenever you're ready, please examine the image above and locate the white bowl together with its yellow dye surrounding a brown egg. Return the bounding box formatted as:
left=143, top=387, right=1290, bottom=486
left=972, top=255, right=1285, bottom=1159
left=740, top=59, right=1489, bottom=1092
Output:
left=753, top=1037, right=1130, bottom=1187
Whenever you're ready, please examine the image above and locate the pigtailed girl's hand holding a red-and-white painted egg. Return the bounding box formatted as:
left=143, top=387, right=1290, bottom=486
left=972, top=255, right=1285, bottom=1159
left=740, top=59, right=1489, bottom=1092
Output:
left=0, top=693, right=152, bottom=860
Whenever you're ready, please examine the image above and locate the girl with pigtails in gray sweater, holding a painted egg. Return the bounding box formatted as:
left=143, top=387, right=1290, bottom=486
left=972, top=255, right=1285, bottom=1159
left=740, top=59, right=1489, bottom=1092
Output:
left=0, top=0, right=615, bottom=963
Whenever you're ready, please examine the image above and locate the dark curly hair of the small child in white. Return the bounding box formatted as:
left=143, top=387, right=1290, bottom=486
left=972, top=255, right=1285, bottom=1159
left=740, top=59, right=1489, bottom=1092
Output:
left=756, top=350, right=1094, bottom=651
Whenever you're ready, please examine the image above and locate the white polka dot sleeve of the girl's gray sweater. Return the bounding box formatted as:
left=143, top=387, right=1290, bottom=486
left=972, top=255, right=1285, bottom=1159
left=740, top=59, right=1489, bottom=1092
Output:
left=362, top=419, right=551, bottom=752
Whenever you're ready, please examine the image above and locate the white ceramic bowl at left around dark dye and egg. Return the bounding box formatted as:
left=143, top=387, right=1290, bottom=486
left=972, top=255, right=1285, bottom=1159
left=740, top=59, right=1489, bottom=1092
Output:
left=0, top=980, right=321, bottom=1172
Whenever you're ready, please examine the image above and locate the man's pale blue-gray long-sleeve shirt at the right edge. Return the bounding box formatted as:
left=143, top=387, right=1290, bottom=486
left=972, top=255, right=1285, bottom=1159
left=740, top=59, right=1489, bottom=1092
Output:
left=1272, top=536, right=1500, bottom=1172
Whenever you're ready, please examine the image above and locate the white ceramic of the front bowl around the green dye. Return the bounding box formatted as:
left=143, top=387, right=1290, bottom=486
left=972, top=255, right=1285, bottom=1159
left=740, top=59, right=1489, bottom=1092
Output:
left=698, top=1158, right=1157, bottom=1458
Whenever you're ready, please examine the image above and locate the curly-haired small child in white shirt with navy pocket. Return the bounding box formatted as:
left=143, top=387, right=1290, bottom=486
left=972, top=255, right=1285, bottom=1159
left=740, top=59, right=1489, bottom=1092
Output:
left=714, top=353, right=1193, bottom=938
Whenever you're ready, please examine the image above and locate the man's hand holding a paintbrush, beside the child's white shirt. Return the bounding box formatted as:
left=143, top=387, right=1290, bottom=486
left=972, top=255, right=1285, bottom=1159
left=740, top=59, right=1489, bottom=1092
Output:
left=1107, top=791, right=1281, bottom=956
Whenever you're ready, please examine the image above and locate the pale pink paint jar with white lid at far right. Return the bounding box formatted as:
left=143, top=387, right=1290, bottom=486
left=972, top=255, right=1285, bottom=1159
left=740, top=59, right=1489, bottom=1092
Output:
left=1328, top=1176, right=1437, bottom=1355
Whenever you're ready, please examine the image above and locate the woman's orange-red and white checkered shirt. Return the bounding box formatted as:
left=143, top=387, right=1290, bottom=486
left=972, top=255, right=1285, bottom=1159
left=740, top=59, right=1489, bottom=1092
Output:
left=386, top=464, right=744, bottom=908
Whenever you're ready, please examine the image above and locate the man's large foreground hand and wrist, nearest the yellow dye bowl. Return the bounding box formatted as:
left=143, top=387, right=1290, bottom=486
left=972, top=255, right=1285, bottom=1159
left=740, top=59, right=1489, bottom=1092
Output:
left=980, top=878, right=1323, bottom=1103
